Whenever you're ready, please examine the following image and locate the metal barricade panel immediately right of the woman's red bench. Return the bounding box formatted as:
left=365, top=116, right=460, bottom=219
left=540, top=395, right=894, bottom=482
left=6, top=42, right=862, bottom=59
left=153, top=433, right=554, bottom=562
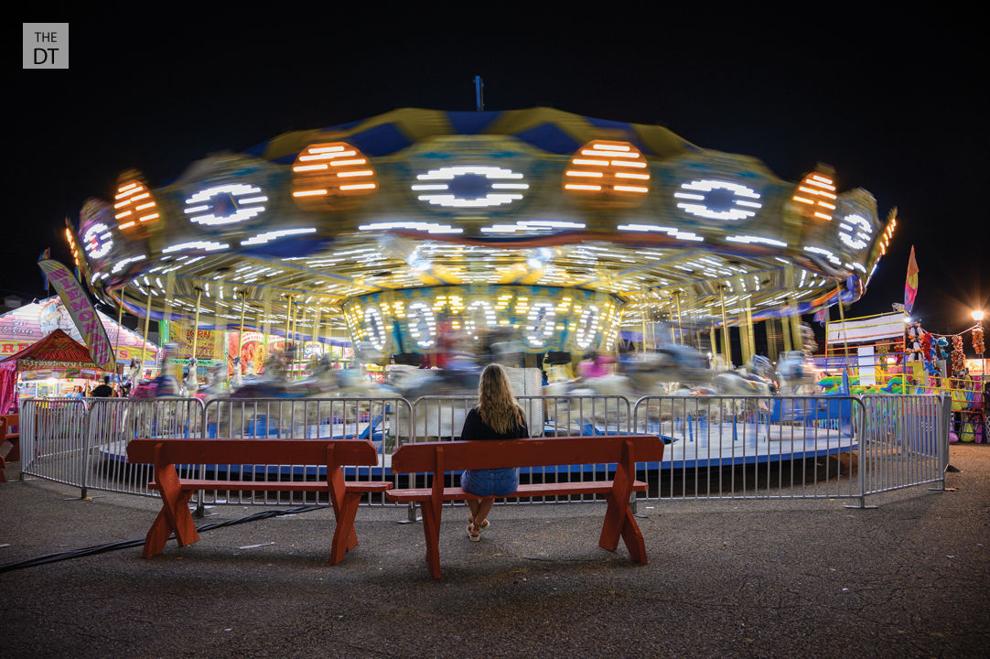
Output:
left=632, top=396, right=864, bottom=500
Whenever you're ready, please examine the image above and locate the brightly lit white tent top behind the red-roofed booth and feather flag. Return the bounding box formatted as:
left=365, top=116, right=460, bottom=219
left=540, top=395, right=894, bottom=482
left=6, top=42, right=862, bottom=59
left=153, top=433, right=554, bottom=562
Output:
left=0, top=296, right=158, bottom=376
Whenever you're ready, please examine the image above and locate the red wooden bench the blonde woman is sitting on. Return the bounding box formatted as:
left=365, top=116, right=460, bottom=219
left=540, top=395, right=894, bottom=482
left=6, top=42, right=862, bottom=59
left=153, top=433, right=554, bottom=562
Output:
left=386, top=435, right=663, bottom=579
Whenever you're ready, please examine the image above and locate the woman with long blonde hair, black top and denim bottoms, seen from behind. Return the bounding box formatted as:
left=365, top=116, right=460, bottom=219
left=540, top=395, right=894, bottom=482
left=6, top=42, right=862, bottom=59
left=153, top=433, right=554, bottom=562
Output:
left=461, top=364, right=529, bottom=542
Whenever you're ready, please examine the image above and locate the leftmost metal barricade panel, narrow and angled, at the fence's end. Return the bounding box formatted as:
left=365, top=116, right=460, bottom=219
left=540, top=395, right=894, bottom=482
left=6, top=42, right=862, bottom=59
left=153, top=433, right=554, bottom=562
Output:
left=20, top=398, right=89, bottom=487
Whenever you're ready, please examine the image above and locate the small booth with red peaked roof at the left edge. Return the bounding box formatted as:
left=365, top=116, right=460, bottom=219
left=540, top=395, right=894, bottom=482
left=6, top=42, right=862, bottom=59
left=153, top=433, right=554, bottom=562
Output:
left=0, top=329, right=102, bottom=414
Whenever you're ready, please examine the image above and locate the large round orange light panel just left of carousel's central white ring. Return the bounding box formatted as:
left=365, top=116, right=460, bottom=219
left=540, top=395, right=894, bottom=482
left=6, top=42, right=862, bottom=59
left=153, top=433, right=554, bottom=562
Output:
left=292, top=142, right=378, bottom=210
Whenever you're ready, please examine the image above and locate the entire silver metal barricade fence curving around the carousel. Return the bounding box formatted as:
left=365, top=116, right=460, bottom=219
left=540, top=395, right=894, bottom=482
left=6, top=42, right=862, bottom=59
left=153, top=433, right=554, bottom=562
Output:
left=11, top=395, right=951, bottom=506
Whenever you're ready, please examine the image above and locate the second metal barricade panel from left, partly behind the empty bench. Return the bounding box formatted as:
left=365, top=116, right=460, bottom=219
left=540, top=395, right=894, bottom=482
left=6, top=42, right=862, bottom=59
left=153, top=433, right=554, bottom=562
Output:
left=83, top=398, right=203, bottom=496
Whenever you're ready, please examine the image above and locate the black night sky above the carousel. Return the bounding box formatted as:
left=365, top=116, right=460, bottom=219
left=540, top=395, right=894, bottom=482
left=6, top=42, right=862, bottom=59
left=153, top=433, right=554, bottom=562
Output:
left=9, top=11, right=990, bottom=332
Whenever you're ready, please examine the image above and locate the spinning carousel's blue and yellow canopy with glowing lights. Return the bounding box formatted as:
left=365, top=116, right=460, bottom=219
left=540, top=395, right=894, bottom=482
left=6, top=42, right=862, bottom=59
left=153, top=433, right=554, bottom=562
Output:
left=67, top=108, right=896, bottom=352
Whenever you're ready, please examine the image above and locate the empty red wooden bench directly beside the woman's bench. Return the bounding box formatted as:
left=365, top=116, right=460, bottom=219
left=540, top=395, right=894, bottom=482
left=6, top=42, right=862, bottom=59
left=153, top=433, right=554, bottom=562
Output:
left=127, top=439, right=392, bottom=565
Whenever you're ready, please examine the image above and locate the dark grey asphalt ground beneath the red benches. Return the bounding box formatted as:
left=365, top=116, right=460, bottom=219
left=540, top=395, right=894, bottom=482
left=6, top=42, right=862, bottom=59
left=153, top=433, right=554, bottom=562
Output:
left=0, top=445, right=990, bottom=657
